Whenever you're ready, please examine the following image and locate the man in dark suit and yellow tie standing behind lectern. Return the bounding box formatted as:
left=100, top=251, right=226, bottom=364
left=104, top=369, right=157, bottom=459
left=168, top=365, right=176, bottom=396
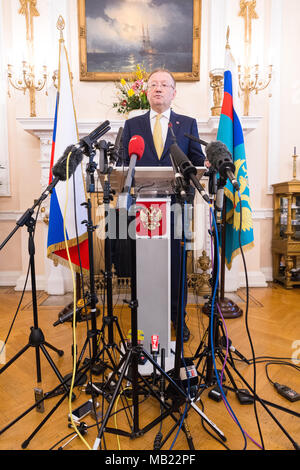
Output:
left=123, top=69, right=205, bottom=341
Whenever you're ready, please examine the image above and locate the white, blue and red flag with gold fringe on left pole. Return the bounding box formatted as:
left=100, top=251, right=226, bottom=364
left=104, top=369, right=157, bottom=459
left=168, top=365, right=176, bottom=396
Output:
left=47, top=38, right=89, bottom=273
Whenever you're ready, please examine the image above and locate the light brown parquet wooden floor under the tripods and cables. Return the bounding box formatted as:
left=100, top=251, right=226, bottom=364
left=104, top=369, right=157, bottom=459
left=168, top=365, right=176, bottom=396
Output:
left=0, top=284, right=300, bottom=451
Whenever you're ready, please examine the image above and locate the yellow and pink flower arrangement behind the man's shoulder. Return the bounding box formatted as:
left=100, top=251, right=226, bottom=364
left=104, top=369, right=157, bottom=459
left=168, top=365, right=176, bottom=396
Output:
left=113, top=64, right=150, bottom=114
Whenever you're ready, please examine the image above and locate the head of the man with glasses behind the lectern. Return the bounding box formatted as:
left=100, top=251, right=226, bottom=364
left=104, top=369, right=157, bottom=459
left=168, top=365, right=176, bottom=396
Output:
left=147, top=72, right=176, bottom=113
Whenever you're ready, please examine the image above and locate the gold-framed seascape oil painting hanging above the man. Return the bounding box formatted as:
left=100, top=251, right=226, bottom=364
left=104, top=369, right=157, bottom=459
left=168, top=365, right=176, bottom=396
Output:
left=78, top=0, right=201, bottom=81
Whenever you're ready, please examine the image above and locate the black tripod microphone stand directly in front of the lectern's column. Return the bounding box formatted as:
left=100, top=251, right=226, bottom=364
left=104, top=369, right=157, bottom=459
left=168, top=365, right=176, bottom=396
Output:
left=93, top=162, right=226, bottom=450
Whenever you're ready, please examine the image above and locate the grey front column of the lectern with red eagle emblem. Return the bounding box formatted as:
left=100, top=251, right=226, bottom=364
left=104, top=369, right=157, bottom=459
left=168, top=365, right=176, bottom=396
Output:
left=136, top=196, right=171, bottom=372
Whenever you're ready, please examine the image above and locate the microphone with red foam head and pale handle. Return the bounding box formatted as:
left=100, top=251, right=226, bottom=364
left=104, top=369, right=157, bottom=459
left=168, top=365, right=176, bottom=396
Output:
left=117, top=135, right=145, bottom=209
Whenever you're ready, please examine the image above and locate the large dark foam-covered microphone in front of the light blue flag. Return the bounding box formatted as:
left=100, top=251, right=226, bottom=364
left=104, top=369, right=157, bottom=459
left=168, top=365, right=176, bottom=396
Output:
left=206, top=140, right=240, bottom=191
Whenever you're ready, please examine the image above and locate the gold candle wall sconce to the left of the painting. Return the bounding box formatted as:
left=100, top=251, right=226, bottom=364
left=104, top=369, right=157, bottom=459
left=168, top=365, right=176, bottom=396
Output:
left=7, top=0, right=47, bottom=117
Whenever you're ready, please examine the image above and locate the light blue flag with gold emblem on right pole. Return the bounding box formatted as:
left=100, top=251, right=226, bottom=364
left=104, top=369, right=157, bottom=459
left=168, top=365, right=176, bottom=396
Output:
left=217, top=38, right=254, bottom=269
